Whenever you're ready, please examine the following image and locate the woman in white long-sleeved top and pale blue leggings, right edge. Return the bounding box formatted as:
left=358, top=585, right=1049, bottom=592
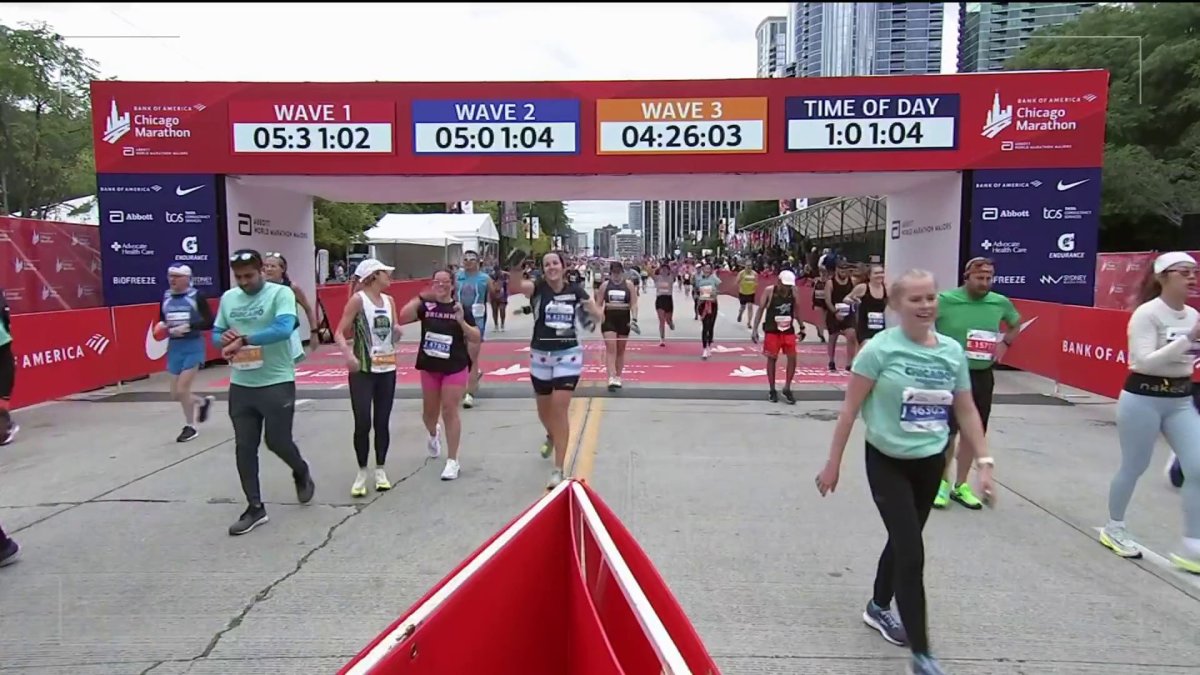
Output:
left=1100, top=251, right=1200, bottom=574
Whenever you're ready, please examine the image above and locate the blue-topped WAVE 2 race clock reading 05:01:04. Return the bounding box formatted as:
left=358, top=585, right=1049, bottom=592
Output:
left=413, top=98, right=580, bottom=155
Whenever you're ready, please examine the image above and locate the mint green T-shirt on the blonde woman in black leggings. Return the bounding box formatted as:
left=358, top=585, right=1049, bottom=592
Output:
left=851, top=327, right=971, bottom=459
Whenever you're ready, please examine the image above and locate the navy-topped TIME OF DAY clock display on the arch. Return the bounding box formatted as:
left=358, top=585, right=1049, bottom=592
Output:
left=784, top=94, right=959, bottom=153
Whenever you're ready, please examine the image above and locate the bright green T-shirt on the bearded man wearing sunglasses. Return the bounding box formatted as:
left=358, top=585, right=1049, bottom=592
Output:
left=936, top=286, right=1021, bottom=370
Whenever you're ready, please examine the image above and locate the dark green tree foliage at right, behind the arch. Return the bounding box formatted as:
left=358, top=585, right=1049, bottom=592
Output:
left=1006, top=2, right=1200, bottom=250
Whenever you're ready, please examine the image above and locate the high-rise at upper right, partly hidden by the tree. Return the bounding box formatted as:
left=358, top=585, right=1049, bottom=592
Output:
left=958, top=2, right=1099, bottom=72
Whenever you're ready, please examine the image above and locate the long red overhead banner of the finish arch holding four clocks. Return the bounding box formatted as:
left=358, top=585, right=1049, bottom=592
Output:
left=92, top=71, right=1108, bottom=176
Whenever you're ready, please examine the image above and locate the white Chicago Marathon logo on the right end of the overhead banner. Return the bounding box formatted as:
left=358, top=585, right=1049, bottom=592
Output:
left=979, top=90, right=1098, bottom=153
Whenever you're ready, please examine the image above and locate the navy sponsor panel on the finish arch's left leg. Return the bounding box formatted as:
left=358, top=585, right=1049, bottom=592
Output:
left=96, top=174, right=221, bottom=306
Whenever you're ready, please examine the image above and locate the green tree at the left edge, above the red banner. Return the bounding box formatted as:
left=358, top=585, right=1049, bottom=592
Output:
left=0, top=24, right=97, bottom=217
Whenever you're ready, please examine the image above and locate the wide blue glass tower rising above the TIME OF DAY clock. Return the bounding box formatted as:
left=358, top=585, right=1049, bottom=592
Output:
left=786, top=2, right=944, bottom=77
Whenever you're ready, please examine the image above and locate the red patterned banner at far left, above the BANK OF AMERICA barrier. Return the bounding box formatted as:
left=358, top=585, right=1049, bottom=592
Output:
left=0, top=216, right=103, bottom=313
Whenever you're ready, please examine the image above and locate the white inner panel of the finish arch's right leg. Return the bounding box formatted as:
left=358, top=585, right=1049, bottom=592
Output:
left=883, top=173, right=962, bottom=288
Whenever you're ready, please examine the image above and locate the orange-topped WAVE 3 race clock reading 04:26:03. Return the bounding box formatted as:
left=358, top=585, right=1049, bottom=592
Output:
left=596, top=97, right=767, bottom=155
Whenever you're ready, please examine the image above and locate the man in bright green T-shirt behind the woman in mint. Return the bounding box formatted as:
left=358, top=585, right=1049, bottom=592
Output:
left=934, top=258, right=1021, bottom=510
